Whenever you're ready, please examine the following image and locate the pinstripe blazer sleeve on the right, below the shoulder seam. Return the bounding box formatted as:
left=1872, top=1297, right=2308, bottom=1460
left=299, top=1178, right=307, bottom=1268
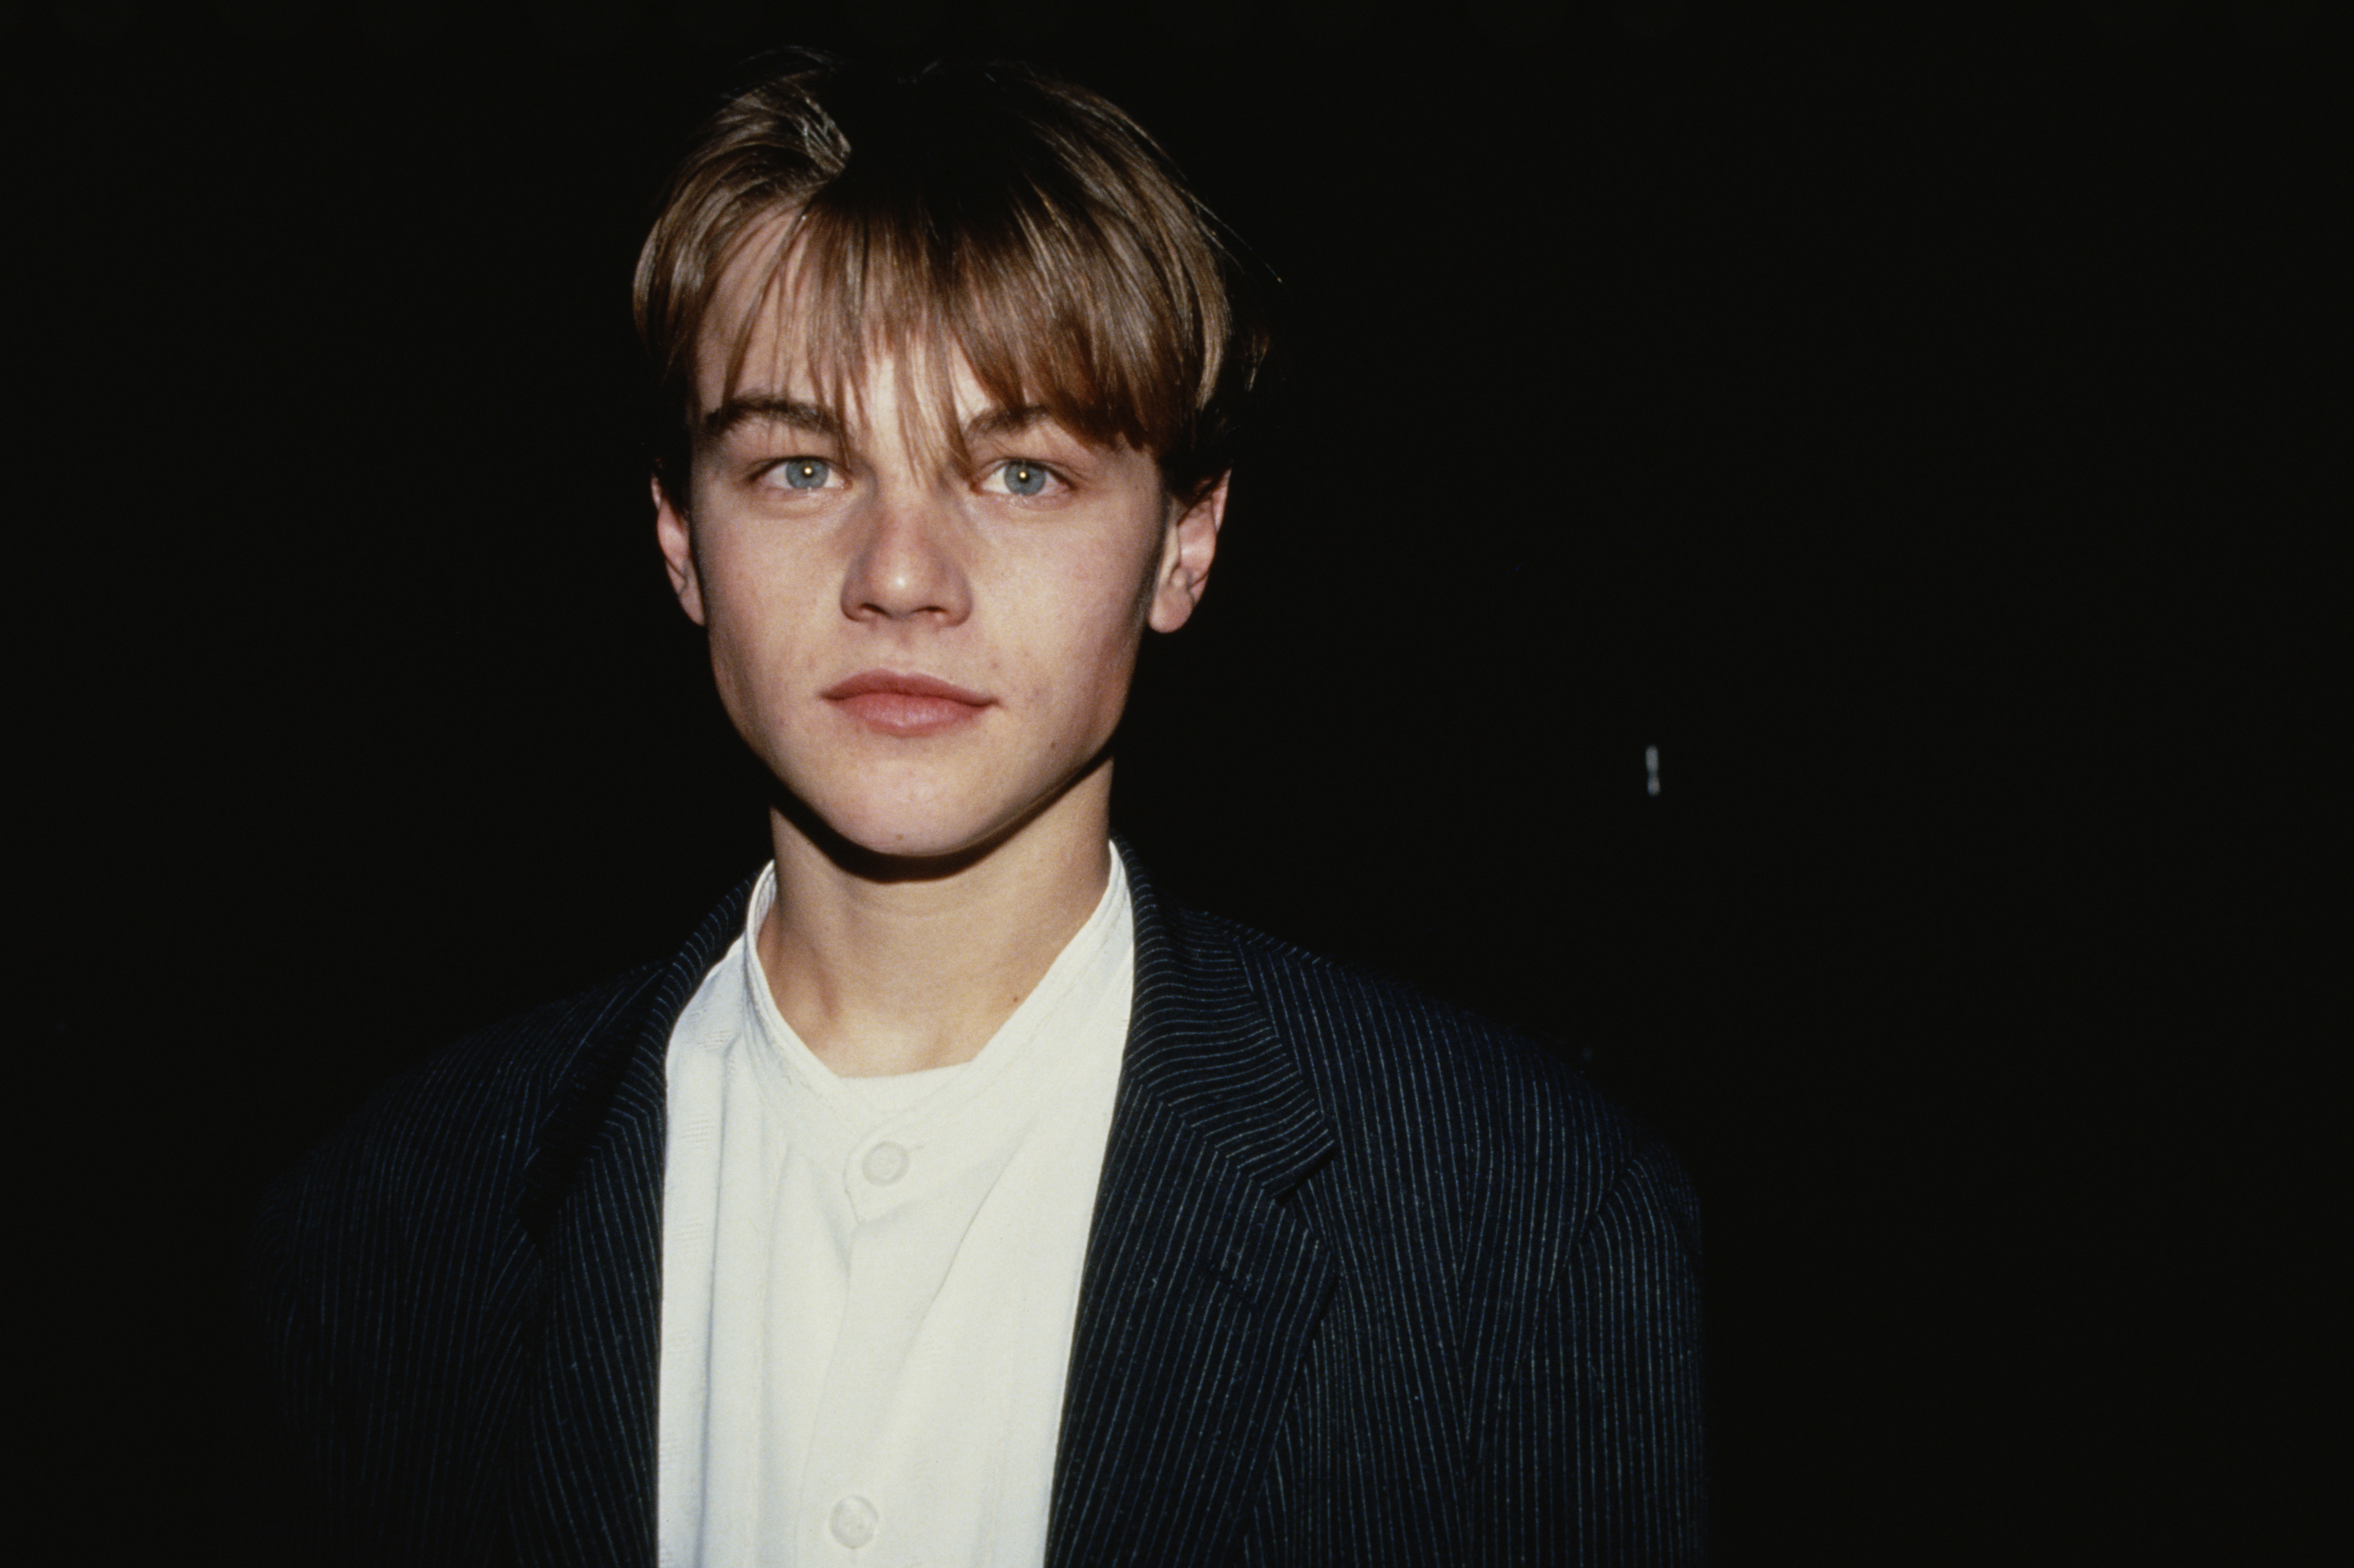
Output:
left=1480, top=1144, right=1707, bottom=1568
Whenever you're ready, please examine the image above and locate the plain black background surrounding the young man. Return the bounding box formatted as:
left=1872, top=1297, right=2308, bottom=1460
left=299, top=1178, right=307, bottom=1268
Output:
left=18, top=0, right=2347, bottom=1563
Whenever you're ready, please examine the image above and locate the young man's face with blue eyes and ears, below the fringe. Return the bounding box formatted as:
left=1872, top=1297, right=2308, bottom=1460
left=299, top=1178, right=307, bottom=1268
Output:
left=654, top=247, right=1224, bottom=857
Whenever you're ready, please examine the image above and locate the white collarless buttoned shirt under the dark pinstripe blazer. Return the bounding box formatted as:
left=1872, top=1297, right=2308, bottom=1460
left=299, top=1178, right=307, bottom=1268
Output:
left=657, top=855, right=1135, bottom=1568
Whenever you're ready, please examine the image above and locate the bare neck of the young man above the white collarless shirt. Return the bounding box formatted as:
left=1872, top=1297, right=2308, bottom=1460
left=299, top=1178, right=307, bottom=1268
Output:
left=758, top=765, right=1111, bottom=1078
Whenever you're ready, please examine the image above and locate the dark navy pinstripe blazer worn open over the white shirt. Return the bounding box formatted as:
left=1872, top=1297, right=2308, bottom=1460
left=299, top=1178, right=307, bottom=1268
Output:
left=233, top=845, right=1702, bottom=1568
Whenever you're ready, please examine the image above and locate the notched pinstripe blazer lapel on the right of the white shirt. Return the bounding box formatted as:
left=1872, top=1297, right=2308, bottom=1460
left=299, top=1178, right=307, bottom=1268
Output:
left=1045, top=845, right=1335, bottom=1568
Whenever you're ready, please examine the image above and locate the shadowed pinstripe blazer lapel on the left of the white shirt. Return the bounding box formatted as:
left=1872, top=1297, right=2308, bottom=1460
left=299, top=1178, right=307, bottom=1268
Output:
left=509, top=883, right=751, bottom=1568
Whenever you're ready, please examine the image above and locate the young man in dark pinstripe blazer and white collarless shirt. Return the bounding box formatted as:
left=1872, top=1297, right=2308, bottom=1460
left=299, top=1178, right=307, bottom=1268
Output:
left=239, top=61, right=1702, bottom=1568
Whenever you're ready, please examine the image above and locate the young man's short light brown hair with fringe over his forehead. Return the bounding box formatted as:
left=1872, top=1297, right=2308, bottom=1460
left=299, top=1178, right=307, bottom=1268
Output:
left=635, top=54, right=1269, bottom=499
